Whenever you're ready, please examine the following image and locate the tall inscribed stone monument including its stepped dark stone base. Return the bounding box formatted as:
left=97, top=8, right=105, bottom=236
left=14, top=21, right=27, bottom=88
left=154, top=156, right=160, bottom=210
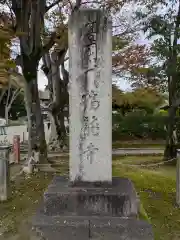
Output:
left=33, top=9, right=153, bottom=240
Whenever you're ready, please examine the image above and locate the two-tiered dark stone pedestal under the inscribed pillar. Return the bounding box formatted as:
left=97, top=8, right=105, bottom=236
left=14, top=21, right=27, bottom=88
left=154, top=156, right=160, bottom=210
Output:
left=33, top=176, right=153, bottom=240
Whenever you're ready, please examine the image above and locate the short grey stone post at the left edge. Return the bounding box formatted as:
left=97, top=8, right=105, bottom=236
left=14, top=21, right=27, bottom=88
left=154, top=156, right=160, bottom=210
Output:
left=0, top=146, right=10, bottom=201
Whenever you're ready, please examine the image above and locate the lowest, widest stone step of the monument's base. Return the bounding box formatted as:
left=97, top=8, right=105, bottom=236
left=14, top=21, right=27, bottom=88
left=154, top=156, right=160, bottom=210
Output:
left=33, top=214, right=153, bottom=240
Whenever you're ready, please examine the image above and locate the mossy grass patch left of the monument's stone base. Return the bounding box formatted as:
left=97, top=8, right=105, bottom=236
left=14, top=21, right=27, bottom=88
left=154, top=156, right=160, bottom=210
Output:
left=0, top=173, right=53, bottom=240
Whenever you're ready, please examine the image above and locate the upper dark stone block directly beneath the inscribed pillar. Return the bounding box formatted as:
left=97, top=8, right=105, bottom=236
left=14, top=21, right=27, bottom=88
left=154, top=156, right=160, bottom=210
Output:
left=44, top=176, right=139, bottom=217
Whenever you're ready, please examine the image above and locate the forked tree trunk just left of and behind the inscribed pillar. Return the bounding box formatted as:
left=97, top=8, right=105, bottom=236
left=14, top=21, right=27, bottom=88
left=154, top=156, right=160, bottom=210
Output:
left=43, top=49, right=68, bottom=150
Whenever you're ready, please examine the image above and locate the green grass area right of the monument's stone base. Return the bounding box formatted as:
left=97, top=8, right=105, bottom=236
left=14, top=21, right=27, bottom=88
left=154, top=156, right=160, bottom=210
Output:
left=113, top=157, right=180, bottom=240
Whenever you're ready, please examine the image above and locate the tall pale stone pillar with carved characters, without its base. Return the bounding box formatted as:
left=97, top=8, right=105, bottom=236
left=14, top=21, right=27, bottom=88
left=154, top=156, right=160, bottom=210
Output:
left=69, top=9, right=112, bottom=182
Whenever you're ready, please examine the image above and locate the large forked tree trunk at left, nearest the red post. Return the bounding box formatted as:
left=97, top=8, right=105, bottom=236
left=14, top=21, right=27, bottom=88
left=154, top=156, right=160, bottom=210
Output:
left=11, top=0, right=57, bottom=174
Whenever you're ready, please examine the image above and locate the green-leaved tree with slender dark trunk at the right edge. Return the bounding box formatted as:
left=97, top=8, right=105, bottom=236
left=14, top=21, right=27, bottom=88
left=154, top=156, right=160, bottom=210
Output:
left=133, top=0, right=180, bottom=159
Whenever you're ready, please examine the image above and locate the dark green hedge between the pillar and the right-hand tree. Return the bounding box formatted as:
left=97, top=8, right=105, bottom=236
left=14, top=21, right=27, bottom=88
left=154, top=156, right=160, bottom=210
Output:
left=112, top=113, right=168, bottom=141
